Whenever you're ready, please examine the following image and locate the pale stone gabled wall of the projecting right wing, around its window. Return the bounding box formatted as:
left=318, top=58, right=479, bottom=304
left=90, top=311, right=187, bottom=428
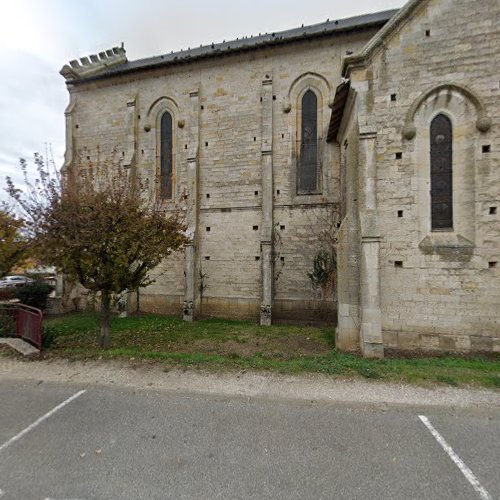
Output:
left=344, top=0, right=500, bottom=351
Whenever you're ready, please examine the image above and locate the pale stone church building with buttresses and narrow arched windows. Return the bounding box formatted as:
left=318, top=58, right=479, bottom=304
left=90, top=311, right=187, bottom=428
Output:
left=61, top=0, right=500, bottom=357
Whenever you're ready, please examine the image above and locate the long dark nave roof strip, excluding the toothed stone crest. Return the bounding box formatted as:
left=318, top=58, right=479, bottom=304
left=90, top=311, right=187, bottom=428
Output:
left=66, top=9, right=398, bottom=83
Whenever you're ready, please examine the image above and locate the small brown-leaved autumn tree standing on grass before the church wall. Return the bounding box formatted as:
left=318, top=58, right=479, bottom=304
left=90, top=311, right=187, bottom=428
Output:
left=7, top=154, right=188, bottom=348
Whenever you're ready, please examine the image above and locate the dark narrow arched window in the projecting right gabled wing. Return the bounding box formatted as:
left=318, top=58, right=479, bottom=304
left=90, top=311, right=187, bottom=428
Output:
left=430, top=114, right=453, bottom=230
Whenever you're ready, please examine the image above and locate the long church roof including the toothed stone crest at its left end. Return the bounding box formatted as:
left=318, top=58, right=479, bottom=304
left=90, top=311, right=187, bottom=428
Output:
left=61, top=10, right=398, bottom=83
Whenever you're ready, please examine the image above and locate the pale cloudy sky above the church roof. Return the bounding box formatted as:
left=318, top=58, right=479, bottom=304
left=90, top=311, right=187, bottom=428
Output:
left=0, top=0, right=404, bottom=200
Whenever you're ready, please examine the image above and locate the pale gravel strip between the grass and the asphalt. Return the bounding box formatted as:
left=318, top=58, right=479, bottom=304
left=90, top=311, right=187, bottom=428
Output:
left=0, top=358, right=500, bottom=414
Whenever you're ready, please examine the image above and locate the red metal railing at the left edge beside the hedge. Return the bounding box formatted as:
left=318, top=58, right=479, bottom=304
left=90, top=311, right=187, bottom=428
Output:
left=0, top=303, right=43, bottom=349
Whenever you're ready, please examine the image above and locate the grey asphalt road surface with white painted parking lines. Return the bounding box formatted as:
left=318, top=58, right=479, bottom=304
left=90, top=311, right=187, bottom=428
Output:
left=0, top=380, right=500, bottom=500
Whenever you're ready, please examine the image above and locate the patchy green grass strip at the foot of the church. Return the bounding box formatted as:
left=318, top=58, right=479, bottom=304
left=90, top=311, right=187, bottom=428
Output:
left=44, top=313, right=500, bottom=389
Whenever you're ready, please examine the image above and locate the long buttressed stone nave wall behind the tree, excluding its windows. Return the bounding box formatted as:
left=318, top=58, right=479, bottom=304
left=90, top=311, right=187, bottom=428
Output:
left=66, top=28, right=375, bottom=321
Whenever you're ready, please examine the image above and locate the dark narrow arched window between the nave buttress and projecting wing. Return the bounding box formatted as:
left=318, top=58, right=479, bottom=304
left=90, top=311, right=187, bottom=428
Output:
left=297, top=90, right=318, bottom=193
